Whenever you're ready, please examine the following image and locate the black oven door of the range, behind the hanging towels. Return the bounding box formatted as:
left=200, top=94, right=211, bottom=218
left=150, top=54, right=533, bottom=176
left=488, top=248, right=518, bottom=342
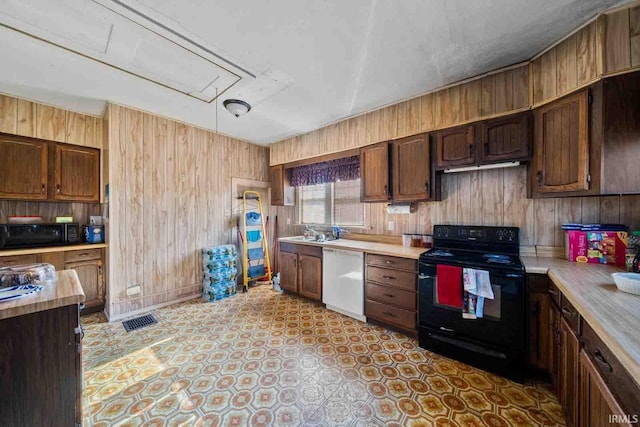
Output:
left=418, top=263, right=525, bottom=350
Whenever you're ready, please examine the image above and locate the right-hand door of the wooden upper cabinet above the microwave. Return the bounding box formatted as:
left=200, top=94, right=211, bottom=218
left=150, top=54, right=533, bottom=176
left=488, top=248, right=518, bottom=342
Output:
left=53, top=144, right=100, bottom=202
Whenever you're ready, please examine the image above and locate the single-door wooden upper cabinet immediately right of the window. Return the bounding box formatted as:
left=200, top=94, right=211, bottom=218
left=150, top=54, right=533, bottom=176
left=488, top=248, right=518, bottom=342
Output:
left=360, top=142, right=391, bottom=202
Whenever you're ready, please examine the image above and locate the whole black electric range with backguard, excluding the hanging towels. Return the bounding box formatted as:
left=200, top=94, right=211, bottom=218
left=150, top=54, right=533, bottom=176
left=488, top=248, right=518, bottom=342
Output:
left=418, top=225, right=526, bottom=381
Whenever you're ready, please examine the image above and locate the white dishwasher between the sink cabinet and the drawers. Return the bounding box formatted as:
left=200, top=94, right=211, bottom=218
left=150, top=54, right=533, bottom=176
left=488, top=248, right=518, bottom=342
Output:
left=322, top=248, right=367, bottom=322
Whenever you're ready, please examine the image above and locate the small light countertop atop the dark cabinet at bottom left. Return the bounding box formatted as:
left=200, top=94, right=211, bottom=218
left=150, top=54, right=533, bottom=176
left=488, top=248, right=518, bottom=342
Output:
left=0, top=270, right=84, bottom=320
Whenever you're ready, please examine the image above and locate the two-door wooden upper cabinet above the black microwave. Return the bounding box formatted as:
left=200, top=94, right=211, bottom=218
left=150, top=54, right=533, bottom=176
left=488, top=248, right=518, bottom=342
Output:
left=0, top=134, right=100, bottom=203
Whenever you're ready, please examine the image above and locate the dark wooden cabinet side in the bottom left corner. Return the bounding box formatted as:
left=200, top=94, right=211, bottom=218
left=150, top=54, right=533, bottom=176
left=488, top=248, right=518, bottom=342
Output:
left=0, top=305, right=82, bottom=426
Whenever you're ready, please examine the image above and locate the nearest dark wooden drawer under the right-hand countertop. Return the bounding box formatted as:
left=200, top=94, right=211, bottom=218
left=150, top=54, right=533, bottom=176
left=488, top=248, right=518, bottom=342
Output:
left=581, top=319, right=640, bottom=413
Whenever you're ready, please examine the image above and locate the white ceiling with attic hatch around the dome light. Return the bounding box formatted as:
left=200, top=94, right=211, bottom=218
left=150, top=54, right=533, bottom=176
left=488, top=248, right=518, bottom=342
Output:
left=0, top=0, right=626, bottom=144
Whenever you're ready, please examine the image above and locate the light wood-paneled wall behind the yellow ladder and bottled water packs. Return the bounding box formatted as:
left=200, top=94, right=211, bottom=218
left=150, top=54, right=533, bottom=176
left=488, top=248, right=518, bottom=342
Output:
left=107, top=105, right=269, bottom=318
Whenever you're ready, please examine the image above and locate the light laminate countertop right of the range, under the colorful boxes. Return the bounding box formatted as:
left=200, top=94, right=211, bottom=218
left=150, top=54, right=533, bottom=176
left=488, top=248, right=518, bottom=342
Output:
left=521, top=257, right=640, bottom=384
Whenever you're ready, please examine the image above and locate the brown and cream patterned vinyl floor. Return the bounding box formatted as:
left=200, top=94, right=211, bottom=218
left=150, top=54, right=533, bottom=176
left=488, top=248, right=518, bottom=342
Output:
left=83, top=287, right=564, bottom=427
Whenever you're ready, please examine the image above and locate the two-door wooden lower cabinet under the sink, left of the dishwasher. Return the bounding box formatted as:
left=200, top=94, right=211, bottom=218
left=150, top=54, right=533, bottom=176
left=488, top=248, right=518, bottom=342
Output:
left=278, top=243, right=322, bottom=301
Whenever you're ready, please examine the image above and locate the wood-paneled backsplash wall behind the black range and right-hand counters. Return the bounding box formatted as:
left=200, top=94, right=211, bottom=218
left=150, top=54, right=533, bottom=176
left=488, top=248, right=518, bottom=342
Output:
left=277, top=166, right=640, bottom=255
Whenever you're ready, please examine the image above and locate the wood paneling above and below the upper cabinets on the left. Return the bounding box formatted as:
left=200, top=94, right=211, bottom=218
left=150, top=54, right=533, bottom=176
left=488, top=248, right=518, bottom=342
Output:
left=0, top=95, right=104, bottom=224
